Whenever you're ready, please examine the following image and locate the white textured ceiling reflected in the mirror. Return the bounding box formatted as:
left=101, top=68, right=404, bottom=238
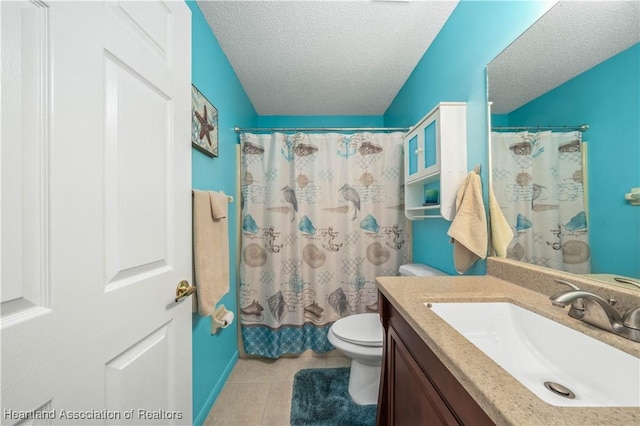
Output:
left=489, top=0, right=640, bottom=114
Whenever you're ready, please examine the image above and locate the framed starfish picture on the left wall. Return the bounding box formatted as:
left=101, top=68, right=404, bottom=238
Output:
left=191, top=84, right=218, bottom=157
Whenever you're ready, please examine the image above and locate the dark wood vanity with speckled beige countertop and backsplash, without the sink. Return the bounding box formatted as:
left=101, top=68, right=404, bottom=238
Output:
left=377, top=259, right=640, bottom=425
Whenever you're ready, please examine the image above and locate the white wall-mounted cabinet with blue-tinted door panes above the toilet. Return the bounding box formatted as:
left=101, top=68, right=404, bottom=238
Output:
left=404, top=102, right=467, bottom=220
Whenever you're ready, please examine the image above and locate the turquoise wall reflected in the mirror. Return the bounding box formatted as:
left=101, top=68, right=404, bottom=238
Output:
left=508, top=44, right=640, bottom=277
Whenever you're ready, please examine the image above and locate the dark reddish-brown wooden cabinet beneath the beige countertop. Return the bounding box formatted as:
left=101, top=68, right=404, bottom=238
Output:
left=376, top=293, right=494, bottom=426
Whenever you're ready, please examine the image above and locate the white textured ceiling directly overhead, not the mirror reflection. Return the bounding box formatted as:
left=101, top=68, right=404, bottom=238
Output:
left=197, top=0, right=457, bottom=115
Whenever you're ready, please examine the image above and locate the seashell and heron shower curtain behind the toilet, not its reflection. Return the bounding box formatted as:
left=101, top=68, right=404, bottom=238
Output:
left=239, top=133, right=410, bottom=358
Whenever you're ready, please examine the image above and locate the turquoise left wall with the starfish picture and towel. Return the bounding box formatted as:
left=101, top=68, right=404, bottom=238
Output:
left=187, top=1, right=258, bottom=424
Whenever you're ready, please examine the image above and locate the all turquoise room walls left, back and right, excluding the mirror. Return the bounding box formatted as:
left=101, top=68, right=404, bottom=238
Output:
left=187, top=0, right=568, bottom=424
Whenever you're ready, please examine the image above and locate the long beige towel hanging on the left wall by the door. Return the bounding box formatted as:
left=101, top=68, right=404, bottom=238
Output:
left=193, top=189, right=229, bottom=331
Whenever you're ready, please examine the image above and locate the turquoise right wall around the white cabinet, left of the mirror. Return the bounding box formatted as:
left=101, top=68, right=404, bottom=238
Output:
left=384, top=0, right=551, bottom=275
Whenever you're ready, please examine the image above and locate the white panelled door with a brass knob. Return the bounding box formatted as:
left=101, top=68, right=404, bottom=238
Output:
left=0, top=0, right=192, bottom=424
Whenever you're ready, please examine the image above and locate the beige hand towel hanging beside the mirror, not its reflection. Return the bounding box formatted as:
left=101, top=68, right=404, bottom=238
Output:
left=447, top=172, right=488, bottom=274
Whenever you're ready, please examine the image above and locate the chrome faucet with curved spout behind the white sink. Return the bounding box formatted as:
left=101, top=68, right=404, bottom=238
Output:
left=549, top=287, right=640, bottom=342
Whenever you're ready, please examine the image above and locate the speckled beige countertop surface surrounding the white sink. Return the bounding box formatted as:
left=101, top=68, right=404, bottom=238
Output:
left=377, top=275, right=640, bottom=425
